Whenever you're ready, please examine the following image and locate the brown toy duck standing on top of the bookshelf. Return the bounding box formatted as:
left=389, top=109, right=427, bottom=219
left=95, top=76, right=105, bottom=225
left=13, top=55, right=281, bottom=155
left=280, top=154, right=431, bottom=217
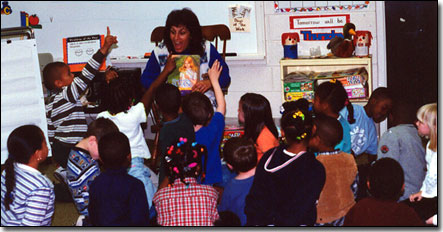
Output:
left=327, top=23, right=355, bottom=57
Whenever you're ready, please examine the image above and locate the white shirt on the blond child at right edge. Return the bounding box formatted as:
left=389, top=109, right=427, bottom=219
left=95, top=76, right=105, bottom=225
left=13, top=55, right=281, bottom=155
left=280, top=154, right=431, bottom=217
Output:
left=420, top=142, right=437, bottom=198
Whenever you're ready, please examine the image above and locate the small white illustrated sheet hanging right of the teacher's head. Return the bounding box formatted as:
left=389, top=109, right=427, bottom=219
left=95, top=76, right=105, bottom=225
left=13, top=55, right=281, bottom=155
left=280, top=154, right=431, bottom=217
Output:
left=229, top=5, right=252, bottom=32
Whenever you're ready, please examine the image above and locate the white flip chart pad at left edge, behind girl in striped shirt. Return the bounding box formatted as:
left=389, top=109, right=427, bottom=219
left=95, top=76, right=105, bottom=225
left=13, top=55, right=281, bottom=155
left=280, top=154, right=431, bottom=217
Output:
left=1, top=39, right=51, bottom=164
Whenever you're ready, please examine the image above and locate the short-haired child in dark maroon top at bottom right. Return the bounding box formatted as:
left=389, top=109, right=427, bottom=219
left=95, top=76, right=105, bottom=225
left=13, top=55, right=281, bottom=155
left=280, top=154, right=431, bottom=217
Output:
left=344, top=158, right=424, bottom=226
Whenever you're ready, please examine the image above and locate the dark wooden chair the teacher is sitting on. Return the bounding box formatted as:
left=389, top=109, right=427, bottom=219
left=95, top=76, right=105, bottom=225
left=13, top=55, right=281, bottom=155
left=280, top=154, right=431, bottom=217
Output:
left=150, top=24, right=231, bottom=167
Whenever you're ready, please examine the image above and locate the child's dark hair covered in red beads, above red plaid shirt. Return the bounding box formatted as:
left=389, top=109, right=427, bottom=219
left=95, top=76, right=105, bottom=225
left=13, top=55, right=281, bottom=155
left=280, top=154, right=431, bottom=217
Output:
left=165, top=138, right=208, bottom=184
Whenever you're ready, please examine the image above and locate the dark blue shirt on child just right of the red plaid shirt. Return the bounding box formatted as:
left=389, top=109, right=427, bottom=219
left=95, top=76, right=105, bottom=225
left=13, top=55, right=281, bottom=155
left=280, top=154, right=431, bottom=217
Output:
left=218, top=176, right=254, bottom=226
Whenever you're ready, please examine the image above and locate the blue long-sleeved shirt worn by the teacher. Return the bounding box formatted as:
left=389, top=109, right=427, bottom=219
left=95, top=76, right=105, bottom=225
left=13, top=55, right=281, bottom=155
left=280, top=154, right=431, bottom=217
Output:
left=141, top=44, right=231, bottom=89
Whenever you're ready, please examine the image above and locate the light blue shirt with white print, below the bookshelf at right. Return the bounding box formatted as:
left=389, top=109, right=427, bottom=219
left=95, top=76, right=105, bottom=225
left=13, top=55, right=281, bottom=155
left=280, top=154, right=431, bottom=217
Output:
left=340, top=104, right=377, bottom=156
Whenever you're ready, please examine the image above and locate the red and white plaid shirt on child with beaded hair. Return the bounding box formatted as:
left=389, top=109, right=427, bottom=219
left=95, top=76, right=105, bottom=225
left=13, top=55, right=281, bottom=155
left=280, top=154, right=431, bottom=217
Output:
left=153, top=178, right=219, bottom=226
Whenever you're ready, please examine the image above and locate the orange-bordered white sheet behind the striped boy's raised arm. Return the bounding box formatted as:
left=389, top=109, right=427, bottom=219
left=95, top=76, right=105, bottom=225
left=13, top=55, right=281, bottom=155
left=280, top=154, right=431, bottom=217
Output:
left=63, top=35, right=106, bottom=72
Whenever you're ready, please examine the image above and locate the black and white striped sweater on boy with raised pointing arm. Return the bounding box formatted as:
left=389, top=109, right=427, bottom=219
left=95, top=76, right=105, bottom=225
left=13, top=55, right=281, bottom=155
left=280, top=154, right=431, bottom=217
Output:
left=46, top=51, right=105, bottom=145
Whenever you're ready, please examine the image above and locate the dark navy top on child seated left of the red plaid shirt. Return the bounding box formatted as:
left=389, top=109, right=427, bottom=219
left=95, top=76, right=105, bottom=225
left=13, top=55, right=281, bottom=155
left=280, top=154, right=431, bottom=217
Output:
left=88, top=168, right=149, bottom=226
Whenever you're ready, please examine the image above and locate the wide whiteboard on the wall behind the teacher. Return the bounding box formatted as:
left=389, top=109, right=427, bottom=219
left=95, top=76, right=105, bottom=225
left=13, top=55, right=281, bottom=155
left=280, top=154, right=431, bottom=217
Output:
left=1, top=1, right=264, bottom=60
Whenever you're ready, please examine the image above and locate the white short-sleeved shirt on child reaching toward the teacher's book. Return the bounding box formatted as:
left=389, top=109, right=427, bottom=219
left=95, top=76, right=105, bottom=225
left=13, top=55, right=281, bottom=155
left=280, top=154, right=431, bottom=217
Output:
left=97, top=102, right=151, bottom=159
